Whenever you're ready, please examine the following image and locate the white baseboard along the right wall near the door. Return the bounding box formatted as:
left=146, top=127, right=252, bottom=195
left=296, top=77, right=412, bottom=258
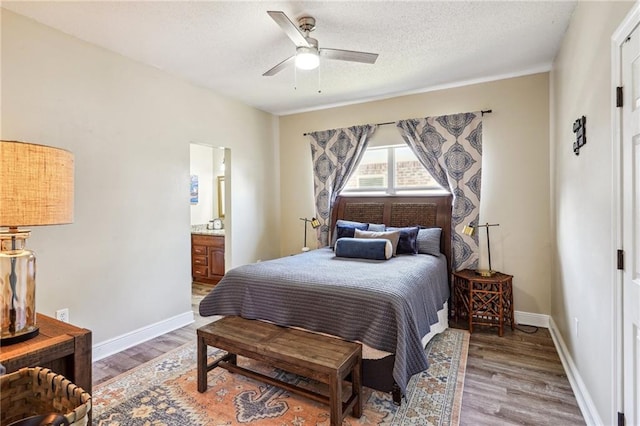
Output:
left=549, top=317, right=605, bottom=426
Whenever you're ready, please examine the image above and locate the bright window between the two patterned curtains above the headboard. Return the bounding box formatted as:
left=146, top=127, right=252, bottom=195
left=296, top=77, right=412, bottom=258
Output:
left=344, top=145, right=442, bottom=194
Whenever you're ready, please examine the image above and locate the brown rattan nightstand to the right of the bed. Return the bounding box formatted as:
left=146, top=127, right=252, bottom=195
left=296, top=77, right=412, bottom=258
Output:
left=453, top=269, right=515, bottom=337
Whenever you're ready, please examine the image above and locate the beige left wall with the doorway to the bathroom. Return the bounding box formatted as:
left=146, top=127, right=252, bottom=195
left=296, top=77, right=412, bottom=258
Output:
left=1, top=10, right=279, bottom=344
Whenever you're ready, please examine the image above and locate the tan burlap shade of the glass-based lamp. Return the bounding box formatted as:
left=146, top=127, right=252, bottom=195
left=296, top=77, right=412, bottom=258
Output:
left=0, top=141, right=73, bottom=227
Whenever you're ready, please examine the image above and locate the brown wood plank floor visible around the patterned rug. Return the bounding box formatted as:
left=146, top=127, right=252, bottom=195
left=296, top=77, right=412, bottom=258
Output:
left=93, top=284, right=585, bottom=426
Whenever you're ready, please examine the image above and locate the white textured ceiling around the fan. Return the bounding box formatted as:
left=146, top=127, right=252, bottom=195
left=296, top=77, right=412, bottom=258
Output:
left=2, top=1, right=576, bottom=115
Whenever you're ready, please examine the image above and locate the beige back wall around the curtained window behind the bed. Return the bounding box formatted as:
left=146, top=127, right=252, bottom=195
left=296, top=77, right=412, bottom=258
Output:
left=280, top=73, right=551, bottom=314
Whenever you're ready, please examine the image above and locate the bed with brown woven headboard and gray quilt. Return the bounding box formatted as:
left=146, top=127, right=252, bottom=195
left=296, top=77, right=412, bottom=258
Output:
left=200, top=194, right=451, bottom=403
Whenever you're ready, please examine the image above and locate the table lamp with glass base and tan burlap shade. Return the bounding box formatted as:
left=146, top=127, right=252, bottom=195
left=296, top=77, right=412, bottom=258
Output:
left=0, top=141, right=73, bottom=346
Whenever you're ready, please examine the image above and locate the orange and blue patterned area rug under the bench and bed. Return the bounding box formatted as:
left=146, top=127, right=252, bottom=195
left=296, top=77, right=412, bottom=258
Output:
left=93, top=329, right=469, bottom=426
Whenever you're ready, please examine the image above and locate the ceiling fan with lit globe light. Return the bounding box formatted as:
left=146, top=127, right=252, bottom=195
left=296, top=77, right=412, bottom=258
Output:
left=262, top=11, right=378, bottom=77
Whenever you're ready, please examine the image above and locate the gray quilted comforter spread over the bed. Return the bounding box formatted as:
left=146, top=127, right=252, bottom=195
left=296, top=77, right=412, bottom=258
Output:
left=200, top=248, right=449, bottom=393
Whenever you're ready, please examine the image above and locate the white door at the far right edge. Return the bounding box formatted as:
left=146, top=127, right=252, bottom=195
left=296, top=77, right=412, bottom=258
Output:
left=622, top=23, right=640, bottom=426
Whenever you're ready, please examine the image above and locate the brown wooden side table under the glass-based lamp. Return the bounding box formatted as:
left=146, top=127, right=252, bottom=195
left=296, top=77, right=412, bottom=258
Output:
left=0, top=314, right=91, bottom=394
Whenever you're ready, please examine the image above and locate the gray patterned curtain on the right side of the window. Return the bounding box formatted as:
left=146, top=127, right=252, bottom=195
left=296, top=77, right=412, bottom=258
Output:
left=396, top=112, right=482, bottom=271
